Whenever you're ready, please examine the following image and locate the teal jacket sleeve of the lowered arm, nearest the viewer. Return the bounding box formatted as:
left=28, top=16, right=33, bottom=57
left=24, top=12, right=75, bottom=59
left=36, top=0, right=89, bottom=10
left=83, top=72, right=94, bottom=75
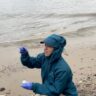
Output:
left=32, top=71, right=68, bottom=96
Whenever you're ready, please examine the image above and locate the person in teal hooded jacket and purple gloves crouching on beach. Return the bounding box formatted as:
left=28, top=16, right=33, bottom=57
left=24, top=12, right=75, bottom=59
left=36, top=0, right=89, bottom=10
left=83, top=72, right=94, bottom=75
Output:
left=20, top=34, right=78, bottom=96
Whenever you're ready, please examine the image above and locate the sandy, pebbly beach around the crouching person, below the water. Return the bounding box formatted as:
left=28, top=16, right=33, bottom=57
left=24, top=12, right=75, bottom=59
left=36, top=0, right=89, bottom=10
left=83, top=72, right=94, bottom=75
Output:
left=0, top=27, right=96, bottom=96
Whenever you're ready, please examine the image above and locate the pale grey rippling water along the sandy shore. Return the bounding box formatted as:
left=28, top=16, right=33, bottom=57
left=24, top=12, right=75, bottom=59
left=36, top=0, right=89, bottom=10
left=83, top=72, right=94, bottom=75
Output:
left=0, top=0, right=96, bottom=43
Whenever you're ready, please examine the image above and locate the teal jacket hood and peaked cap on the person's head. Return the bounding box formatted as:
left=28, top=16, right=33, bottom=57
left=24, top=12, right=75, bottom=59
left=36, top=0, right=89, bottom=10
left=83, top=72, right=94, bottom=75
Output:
left=40, top=34, right=66, bottom=63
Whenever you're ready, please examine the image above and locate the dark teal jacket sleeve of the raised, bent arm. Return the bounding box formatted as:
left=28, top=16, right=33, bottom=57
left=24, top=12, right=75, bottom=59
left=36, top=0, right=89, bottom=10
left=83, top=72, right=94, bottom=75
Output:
left=21, top=53, right=43, bottom=68
